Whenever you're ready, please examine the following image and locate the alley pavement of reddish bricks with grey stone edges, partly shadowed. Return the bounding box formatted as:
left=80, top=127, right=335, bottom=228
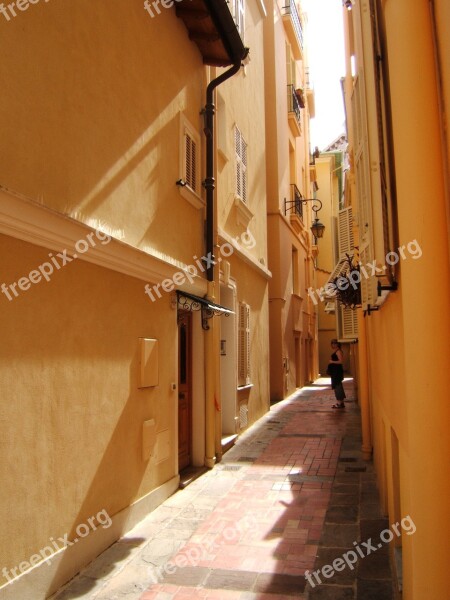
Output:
left=54, top=380, right=395, bottom=600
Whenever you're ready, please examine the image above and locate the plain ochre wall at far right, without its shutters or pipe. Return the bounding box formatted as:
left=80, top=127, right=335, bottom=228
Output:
left=354, top=0, right=450, bottom=600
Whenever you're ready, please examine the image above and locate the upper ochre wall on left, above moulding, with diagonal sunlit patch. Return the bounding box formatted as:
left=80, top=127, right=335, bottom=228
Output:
left=0, top=0, right=205, bottom=264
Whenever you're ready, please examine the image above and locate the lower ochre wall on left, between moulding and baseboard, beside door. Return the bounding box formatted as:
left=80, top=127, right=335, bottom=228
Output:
left=0, top=235, right=177, bottom=580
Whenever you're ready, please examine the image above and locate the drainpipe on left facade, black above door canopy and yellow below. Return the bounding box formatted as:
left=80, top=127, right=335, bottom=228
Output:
left=203, top=58, right=246, bottom=469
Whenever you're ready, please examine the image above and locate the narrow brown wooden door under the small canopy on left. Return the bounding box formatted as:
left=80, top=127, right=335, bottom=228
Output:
left=178, top=312, right=192, bottom=471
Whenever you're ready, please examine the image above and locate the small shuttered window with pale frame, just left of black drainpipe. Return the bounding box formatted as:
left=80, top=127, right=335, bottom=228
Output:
left=179, top=115, right=203, bottom=208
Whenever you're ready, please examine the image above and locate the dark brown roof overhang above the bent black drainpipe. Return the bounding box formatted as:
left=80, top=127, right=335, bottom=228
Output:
left=175, top=0, right=248, bottom=67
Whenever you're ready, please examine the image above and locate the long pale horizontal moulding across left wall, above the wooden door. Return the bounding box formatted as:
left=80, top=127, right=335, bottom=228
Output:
left=0, top=186, right=207, bottom=295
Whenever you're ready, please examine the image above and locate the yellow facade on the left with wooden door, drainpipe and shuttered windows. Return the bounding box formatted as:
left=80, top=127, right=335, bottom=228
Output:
left=0, top=0, right=271, bottom=600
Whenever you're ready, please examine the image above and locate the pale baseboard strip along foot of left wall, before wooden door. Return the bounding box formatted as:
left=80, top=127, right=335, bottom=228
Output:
left=0, top=475, right=180, bottom=600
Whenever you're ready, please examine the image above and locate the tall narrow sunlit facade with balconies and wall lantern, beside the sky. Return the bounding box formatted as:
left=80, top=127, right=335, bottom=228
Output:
left=264, top=1, right=318, bottom=401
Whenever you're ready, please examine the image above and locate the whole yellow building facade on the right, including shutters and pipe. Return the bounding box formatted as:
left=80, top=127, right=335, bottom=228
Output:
left=344, top=0, right=450, bottom=600
